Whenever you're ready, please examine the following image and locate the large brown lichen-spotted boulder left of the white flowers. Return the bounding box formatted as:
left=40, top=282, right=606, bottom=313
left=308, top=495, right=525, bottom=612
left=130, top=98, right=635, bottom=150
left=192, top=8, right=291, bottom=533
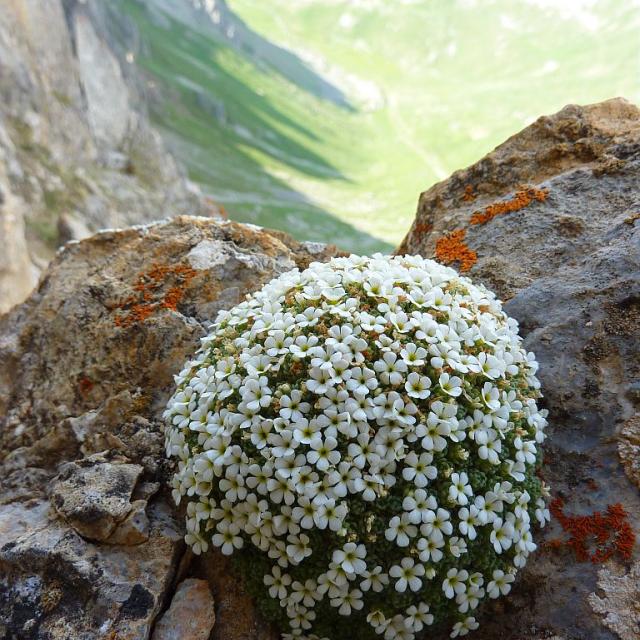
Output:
left=0, top=217, right=337, bottom=640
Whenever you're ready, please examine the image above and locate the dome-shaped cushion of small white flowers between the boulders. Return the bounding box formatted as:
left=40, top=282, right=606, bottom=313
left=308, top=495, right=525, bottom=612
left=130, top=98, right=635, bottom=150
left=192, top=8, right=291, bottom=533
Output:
left=165, top=255, right=549, bottom=640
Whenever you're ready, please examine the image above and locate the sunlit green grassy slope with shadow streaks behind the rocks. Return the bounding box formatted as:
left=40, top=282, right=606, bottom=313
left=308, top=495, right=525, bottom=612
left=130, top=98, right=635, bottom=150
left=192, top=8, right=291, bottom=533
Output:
left=118, top=0, right=640, bottom=253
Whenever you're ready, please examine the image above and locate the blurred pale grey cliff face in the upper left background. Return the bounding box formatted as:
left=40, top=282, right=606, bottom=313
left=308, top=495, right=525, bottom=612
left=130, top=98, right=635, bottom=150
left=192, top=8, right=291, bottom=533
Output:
left=0, top=0, right=216, bottom=312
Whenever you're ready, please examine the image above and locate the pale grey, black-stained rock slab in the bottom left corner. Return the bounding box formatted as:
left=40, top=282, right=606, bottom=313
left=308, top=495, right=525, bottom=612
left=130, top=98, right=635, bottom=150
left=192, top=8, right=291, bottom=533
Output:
left=0, top=502, right=183, bottom=640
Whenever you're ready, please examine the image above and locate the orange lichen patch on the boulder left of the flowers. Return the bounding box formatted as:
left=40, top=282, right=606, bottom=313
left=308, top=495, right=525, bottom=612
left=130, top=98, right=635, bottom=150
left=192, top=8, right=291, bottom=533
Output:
left=115, top=264, right=196, bottom=327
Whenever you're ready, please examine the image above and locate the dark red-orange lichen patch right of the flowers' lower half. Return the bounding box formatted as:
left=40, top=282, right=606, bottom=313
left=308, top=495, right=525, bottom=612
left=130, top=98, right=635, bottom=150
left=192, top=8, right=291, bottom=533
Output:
left=548, top=498, right=636, bottom=563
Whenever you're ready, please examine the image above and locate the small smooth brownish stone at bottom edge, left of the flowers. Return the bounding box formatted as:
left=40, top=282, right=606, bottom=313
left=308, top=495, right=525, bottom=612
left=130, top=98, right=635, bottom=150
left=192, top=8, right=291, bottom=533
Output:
left=152, top=579, right=216, bottom=640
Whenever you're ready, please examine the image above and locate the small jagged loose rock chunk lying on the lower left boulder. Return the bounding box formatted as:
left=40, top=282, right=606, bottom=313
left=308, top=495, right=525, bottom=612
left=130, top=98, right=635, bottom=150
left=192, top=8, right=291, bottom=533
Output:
left=51, top=456, right=148, bottom=544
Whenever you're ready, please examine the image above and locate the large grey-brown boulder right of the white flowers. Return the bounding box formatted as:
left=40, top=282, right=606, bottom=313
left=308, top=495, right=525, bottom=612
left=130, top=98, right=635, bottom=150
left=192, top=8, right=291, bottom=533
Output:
left=398, top=99, right=640, bottom=640
